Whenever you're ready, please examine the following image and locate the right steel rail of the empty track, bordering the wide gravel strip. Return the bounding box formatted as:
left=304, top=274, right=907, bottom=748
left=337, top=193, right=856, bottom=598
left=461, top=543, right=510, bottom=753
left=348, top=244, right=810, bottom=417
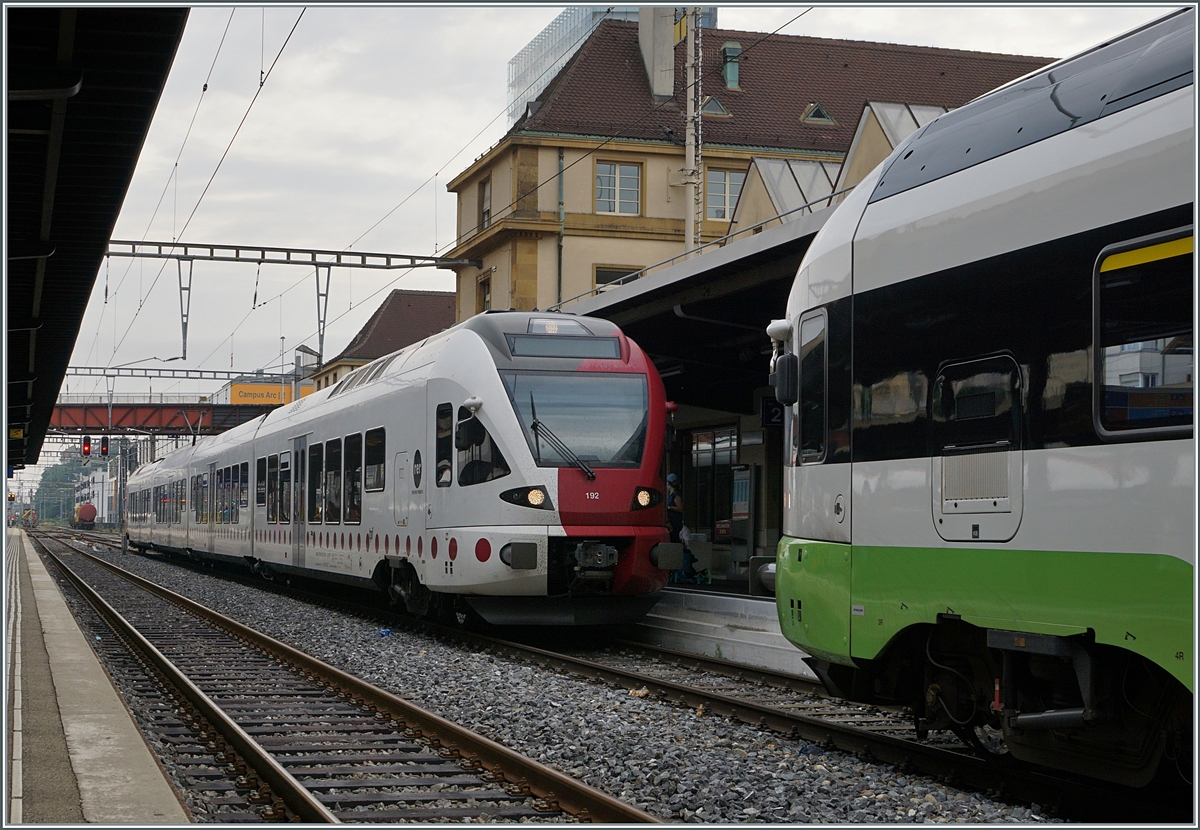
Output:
left=65, top=551, right=662, bottom=824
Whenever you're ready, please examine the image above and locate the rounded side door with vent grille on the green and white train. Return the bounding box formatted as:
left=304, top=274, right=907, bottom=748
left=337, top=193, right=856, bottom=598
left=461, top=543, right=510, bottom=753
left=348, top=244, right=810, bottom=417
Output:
left=930, top=355, right=1024, bottom=542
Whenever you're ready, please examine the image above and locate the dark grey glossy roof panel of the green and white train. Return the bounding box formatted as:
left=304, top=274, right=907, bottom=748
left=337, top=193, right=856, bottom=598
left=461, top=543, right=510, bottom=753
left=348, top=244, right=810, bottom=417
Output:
left=869, top=8, right=1195, bottom=203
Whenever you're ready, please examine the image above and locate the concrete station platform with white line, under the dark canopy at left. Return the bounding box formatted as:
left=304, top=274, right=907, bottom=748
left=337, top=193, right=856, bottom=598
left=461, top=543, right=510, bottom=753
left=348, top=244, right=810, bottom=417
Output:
left=4, top=528, right=191, bottom=826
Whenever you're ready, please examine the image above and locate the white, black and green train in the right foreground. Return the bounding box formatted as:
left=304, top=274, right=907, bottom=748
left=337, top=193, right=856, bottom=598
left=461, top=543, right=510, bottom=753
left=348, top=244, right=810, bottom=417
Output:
left=768, top=8, right=1196, bottom=786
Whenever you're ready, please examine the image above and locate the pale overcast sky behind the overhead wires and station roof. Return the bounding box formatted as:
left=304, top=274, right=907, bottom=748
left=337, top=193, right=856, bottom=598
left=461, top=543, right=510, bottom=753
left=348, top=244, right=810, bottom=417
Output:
left=67, top=4, right=1170, bottom=407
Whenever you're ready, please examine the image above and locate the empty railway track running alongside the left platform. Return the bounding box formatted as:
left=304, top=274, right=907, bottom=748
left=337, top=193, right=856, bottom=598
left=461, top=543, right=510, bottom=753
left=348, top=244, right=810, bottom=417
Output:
left=28, top=534, right=658, bottom=823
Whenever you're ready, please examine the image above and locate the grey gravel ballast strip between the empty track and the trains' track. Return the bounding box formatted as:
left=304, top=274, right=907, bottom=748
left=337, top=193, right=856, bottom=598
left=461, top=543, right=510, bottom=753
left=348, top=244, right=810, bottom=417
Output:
left=79, top=553, right=1055, bottom=824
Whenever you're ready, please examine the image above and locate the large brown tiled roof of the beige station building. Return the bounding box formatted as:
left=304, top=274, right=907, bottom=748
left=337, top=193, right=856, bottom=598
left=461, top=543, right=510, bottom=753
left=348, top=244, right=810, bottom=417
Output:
left=510, top=20, right=1052, bottom=152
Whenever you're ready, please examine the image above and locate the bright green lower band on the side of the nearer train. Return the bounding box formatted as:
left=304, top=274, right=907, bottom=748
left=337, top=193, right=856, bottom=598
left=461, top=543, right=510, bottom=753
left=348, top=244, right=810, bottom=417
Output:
left=775, top=536, right=1194, bottom=691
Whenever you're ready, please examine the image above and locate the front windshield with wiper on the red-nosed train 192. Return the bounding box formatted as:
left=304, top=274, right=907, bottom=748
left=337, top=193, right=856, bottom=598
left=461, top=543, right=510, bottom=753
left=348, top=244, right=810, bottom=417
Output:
left=500, top=372, right=648, bottom=467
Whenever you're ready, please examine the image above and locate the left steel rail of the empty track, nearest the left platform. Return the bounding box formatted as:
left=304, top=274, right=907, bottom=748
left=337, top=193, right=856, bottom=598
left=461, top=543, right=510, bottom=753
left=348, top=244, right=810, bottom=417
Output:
left=35, top=540, right=342, bottom=824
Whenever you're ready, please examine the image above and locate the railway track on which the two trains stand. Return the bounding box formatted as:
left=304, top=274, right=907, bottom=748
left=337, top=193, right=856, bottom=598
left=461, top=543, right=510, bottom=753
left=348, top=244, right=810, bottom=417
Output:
left=44, top=527, right=1192, bottom=822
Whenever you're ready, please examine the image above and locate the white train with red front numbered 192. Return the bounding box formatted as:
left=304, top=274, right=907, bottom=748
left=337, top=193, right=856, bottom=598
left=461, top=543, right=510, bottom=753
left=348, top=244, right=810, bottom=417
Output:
left=126, top=312, right=683, bottom=625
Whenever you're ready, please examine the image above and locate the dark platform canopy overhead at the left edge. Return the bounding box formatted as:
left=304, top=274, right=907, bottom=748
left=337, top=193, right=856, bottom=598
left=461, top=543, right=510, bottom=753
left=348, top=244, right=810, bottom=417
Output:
left=5, top=6, right=188, bottom=469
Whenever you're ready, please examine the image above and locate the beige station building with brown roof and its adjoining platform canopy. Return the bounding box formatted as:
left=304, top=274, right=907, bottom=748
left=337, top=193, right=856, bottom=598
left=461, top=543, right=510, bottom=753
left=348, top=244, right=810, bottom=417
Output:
left=446, top=8, right=1051, bottom=584
